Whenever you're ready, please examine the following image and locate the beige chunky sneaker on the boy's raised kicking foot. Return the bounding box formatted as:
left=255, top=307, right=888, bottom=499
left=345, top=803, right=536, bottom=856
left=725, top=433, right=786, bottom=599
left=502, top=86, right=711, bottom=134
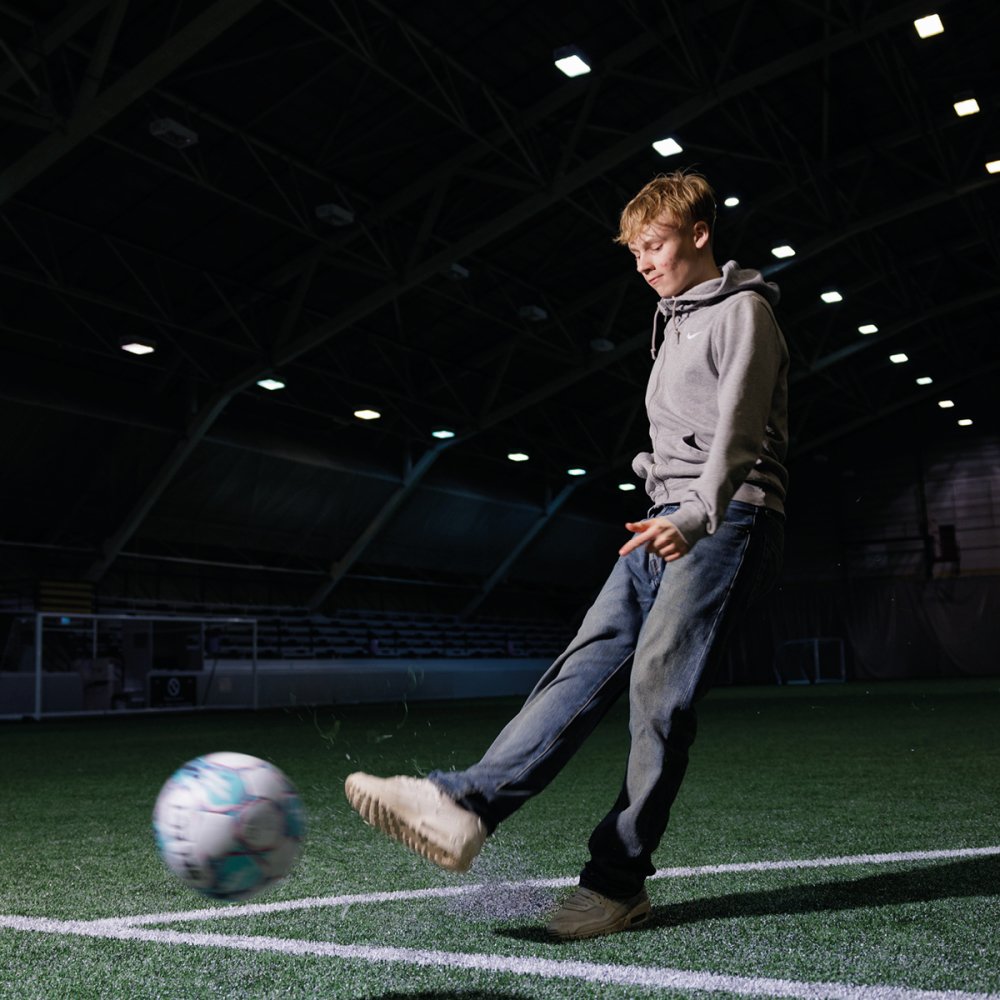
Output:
left=344, top=771, right=487, bottom=872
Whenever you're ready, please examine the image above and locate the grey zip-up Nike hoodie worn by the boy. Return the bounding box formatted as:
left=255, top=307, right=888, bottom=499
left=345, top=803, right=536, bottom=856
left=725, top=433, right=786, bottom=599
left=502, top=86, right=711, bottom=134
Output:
left=632, top=260, right=788, bottom=545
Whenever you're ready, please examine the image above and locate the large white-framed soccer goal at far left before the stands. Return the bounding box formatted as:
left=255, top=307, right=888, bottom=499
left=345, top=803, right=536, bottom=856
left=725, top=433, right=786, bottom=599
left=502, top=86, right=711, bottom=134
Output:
left=0, top=612, right=259, bottom=719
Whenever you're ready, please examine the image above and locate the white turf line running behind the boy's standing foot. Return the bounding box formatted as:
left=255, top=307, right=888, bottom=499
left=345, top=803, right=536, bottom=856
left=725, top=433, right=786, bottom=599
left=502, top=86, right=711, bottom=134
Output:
left=88, top=845, right=1000, bottom=929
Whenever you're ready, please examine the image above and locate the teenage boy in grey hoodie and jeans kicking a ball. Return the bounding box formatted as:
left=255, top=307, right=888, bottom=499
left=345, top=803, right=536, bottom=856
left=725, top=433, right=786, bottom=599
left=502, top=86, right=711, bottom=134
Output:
left=345, top=172, right=788, bottom=939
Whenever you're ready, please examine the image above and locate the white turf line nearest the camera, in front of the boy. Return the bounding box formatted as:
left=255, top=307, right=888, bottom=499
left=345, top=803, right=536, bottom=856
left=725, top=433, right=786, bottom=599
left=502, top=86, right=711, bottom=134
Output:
left=0, top=916, right=997, bottom=1000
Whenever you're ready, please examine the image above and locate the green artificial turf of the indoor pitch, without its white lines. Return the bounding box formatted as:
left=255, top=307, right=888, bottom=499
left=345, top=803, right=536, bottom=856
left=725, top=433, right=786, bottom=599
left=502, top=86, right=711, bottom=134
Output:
left=0, top=680, right=1000, bottom=998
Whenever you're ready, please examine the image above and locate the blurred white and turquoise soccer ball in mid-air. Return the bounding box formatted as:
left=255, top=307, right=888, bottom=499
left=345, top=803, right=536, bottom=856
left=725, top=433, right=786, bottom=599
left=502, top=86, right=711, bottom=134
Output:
left=153, top=753, right=305, bottom=901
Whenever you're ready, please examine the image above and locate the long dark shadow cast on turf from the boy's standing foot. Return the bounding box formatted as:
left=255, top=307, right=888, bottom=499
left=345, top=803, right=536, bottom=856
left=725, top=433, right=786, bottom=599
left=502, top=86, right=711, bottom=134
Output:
left=496, top=856, right=1000, bottom=944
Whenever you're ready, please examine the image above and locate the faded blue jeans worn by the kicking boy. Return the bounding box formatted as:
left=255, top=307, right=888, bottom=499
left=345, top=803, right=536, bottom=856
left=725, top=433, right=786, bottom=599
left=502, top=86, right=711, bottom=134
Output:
left=429, top=501, right=784, bottom=899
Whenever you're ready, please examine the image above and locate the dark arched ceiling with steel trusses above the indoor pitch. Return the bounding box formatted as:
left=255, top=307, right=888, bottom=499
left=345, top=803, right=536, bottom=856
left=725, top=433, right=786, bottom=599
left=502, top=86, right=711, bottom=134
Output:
left=0, top=0, right=1000, bottom=608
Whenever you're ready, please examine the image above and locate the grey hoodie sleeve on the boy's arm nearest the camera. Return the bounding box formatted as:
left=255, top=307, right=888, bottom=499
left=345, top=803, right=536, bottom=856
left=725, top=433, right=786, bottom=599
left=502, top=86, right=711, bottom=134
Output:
left=669, top=294, right=788, bottom=545
